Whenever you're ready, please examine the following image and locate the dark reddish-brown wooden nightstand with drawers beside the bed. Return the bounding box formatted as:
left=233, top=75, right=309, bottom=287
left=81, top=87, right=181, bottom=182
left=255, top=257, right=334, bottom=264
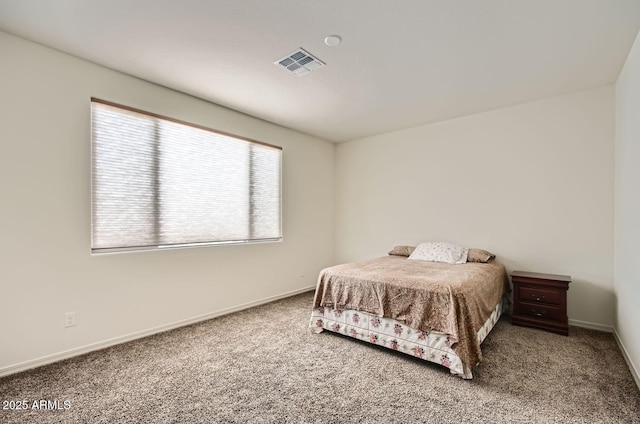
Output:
left=511, top=271, right=571, bottom=336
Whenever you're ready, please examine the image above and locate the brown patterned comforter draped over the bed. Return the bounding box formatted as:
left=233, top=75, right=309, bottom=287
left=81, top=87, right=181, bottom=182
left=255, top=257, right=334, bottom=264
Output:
left=314, top=256, right=509, bottom=368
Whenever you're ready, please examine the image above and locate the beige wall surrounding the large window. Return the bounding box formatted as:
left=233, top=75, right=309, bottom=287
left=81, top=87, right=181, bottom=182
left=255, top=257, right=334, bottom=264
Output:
left=0, top=32, right=335, bottom=375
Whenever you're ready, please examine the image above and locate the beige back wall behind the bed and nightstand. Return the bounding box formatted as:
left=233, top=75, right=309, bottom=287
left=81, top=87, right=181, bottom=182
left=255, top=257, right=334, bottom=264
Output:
left=335, top=86, right=614, bottom=330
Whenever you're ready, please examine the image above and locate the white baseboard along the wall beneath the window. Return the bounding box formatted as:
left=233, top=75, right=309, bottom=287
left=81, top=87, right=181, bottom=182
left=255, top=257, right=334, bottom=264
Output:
left=0, top=285, right=315, bottom=377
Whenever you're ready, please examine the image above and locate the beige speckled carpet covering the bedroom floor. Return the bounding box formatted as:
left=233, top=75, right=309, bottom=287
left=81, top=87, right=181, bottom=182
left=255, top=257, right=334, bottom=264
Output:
left=0, top=293, right=640, bottom=423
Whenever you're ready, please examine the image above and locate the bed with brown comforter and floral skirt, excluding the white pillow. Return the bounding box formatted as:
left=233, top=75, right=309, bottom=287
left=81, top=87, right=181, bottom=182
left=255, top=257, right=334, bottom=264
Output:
left=309, top=244, right=509, bottom=379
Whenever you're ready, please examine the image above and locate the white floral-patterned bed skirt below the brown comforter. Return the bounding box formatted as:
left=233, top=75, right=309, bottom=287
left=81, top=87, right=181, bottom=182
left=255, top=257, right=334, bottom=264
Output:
left=309, top=303, right=502, bottom=379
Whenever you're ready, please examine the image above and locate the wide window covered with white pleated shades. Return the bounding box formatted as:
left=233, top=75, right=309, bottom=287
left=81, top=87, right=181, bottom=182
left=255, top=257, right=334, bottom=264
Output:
left=91, top=99, right=282, bottom=253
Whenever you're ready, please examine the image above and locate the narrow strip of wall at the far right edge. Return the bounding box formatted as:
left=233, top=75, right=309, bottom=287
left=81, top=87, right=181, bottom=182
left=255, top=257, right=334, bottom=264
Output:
left=614, top=30, right=640, bottom=385
